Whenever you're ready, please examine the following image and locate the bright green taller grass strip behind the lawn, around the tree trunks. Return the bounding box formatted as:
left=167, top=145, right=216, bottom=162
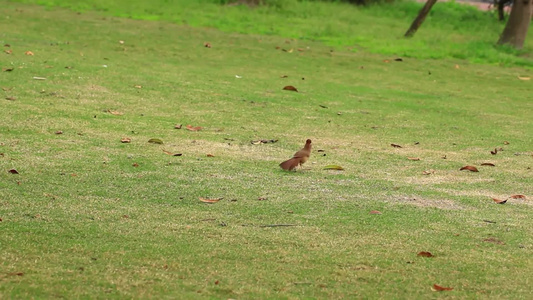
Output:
left=7, top=0, right=533, bottom=69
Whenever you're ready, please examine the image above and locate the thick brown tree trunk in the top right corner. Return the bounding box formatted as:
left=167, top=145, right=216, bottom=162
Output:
left=498, top=0, right=533, bottom=49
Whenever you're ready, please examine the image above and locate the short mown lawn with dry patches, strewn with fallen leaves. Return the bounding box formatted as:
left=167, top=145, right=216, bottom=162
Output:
left=0, top=2, right=533, bottom=299
